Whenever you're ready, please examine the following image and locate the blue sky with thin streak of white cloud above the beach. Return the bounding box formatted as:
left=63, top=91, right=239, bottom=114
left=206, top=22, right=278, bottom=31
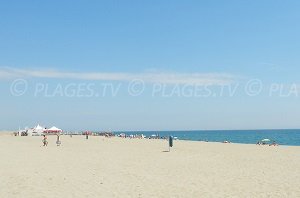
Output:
left=0, top=0, right=300, bottom=131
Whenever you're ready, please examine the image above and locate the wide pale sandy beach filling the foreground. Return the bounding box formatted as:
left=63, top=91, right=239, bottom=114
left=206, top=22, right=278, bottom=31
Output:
left=0, top=134, right=300, bottom=198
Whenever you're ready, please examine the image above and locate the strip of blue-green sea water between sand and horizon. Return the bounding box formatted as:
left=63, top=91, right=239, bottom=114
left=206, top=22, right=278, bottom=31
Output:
left=121, top=129, right=300, bottom=146
